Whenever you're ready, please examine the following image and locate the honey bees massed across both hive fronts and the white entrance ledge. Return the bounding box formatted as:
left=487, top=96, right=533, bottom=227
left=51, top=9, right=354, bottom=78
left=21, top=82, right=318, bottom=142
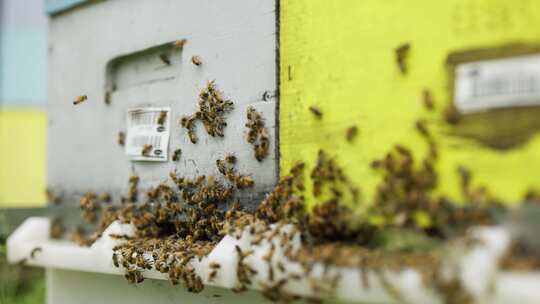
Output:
left=47, top=39, right=540, bottom=303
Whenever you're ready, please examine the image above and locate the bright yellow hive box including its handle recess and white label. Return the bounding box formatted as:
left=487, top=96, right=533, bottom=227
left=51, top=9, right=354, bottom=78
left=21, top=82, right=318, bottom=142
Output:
left=279, top=0, right=540, bottom=209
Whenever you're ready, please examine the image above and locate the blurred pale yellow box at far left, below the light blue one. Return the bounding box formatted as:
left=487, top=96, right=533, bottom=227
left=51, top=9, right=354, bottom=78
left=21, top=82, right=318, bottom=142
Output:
left=0, top=108, right=46, bottom=207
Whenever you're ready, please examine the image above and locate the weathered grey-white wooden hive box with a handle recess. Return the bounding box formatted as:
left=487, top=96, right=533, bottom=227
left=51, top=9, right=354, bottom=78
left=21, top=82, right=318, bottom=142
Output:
left=47, top=0, right=278, bottom=209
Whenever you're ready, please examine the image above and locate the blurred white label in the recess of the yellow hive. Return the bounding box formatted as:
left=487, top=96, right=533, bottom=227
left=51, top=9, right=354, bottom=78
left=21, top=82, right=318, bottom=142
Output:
left=454, top=54, right=540, bottom=113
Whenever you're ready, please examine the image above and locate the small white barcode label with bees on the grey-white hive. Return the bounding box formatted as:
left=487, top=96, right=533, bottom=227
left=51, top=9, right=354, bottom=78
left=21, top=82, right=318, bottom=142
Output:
left=126, top=108, right=171, bottom=161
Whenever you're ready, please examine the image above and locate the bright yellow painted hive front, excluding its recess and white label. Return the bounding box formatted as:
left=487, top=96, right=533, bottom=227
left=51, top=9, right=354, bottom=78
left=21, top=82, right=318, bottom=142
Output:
left=280, top=0, right=540, bottom=207
